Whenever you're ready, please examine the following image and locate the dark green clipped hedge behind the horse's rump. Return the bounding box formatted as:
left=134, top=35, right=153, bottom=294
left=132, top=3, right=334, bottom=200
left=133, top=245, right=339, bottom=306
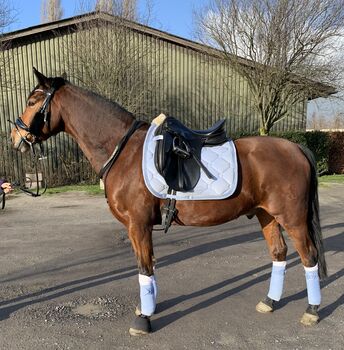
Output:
left=231, top=131, right=330, bottom=175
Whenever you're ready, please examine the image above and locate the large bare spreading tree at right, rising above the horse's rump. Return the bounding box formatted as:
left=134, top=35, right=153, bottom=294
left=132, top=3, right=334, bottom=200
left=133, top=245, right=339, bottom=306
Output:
left=195, top=0, right=344, bottom=135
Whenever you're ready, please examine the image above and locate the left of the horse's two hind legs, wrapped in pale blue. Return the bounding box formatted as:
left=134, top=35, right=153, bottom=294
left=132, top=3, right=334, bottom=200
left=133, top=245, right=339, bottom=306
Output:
left=256, top=209, right=288, bottom=313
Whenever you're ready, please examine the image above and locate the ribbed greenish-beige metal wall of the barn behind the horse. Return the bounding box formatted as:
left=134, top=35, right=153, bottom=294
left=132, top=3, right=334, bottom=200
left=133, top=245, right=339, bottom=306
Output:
left=0, top=16, right=306, bottom=184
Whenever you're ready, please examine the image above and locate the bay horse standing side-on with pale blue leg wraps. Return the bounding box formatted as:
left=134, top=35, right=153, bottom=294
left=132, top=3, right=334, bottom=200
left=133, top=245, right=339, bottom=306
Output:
left=11, top=69, right=327, bottom=335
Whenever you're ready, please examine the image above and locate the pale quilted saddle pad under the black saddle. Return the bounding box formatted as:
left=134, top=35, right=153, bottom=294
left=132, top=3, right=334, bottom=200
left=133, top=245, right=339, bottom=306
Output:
left=142, top=124, right=238, bottom=200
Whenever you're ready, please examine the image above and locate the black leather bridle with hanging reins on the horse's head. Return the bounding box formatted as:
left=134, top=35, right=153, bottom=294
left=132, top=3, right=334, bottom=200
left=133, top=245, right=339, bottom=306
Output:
left=8, top=83, right=56, bottom=197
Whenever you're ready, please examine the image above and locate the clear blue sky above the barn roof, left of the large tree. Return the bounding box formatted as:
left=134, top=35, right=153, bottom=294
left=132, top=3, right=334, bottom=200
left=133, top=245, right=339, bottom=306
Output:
left=9, top=0, right=207, bottom=39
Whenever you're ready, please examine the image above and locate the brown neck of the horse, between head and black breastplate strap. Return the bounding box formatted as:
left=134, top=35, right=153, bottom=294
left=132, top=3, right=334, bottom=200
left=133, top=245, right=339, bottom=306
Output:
left=56, top=85, right=134, bottom=172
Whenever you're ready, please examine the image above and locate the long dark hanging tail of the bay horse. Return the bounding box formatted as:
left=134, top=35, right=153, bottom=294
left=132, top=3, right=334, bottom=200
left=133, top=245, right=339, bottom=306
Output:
left=299, top=145, right=327, bottom=279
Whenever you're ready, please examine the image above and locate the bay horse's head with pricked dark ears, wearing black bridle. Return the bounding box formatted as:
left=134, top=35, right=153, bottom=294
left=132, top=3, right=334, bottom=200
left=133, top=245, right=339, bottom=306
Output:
left=11, top=68, right=66, bottom=152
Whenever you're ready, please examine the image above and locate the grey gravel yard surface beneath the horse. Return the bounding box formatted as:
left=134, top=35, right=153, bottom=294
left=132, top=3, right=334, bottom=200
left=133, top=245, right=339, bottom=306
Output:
left=0, top=185, right=344, bottom=350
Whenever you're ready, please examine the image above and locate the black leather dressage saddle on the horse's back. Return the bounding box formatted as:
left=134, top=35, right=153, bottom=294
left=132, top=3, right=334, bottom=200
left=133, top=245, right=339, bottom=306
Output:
left=154, top=117, right=228, bottom=192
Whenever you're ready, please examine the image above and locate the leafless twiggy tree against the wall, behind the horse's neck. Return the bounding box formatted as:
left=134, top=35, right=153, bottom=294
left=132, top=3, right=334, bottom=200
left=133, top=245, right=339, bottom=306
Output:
left=66, top=3, right=163, bottom=117
